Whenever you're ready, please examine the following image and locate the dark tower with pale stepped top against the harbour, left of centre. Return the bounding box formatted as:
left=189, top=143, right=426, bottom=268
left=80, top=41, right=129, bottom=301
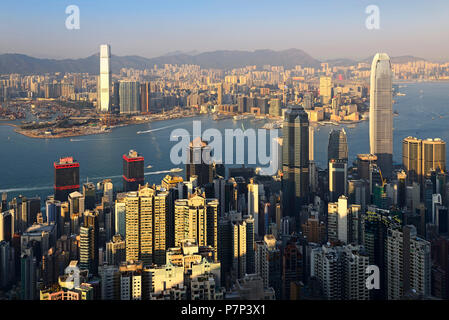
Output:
left=186, top=137, right=213, bottom=186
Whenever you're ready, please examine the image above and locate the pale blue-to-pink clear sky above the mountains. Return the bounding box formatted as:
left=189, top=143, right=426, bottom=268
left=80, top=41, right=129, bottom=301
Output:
left=0, top=0, right=449, bottom=61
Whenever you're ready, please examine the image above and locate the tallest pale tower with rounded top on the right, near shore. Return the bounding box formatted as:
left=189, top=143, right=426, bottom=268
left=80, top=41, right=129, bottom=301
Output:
left=369, top=53, right=393, bottom=177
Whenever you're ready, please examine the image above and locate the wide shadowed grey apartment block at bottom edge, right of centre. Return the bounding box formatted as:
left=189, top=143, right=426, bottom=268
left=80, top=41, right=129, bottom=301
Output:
left=311, top=245, right=369, bottom=300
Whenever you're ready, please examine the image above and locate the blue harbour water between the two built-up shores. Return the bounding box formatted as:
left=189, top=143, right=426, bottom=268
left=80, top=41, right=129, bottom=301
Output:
left=0, top=82, right=449, bottom=201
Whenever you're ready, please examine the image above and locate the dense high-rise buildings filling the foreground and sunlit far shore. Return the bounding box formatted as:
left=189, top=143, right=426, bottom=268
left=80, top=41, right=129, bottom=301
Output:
left=0, top=50, right=449, bottom=300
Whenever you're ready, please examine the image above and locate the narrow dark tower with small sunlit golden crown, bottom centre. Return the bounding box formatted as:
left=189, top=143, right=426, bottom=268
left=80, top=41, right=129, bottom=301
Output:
left=255, top=234, right=282, bottom=299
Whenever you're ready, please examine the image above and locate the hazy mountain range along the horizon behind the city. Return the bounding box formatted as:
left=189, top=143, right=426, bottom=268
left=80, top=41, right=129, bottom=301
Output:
left=0, top=49, right=424, bottom=74
